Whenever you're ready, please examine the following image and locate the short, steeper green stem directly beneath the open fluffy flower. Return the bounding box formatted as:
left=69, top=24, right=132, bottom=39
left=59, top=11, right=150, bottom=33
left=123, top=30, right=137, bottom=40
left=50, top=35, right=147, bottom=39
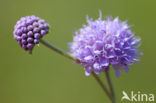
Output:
left=105, top=71, right=117, bottom=103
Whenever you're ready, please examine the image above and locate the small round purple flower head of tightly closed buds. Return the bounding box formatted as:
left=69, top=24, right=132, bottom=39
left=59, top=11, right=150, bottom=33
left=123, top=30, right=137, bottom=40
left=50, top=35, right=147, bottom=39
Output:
left=13, top=15, right=49, bottom=51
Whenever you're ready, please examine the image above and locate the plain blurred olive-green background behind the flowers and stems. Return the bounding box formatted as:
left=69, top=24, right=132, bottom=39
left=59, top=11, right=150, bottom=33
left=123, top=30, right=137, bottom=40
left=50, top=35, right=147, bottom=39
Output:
left=0, top=0, right=156, bottom=103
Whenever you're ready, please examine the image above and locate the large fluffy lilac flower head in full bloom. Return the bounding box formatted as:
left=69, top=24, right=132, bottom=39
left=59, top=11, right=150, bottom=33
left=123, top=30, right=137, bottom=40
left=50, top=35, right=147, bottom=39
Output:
left=70, top=13, right=140, bottom=77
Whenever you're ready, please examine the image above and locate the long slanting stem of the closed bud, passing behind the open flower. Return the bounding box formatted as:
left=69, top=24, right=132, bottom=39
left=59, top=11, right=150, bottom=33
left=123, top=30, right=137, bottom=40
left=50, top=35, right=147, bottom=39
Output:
left=40, top=39, right=113, bottom=103
